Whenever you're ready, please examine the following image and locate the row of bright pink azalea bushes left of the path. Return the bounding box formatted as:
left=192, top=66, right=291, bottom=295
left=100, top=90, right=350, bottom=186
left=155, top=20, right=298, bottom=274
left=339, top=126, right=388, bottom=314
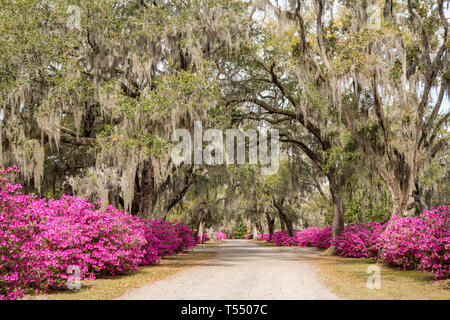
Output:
left=0, top=167, right=195, bottom=299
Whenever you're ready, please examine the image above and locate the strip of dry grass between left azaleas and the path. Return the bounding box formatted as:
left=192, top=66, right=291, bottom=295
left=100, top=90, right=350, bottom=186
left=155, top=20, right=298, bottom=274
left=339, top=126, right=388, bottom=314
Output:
left=24, top=242, right=218, bottom=300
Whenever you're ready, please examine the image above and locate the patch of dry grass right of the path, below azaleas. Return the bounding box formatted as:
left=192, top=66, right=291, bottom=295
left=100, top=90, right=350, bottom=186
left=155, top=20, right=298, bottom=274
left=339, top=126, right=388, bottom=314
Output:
left=313, top=255, right=450, bottom=300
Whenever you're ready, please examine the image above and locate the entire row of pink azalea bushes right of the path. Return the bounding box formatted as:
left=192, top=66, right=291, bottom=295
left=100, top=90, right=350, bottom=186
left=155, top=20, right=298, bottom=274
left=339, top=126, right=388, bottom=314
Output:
left=273, top=206, right=450, bottom=279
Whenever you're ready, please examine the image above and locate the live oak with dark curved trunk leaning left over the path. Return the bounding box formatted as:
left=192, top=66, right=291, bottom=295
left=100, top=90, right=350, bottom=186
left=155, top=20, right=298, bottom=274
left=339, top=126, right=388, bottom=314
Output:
left=221, top=8, right=355, bottom=244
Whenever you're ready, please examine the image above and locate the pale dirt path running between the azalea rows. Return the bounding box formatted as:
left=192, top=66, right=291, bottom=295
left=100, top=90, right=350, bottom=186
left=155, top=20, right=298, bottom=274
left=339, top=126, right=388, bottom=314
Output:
left=119, top=240, right=337, bottom=300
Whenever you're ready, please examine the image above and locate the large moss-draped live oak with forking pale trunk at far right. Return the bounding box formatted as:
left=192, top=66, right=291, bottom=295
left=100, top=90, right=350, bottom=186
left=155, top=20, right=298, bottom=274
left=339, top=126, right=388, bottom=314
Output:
left=258, top=0, right=450, bottom=215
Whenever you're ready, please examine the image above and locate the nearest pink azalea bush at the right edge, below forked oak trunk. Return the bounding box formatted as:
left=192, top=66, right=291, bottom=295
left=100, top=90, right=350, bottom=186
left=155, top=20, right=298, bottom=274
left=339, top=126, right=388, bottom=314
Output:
left=378, top=206, right=450, bottom=279
